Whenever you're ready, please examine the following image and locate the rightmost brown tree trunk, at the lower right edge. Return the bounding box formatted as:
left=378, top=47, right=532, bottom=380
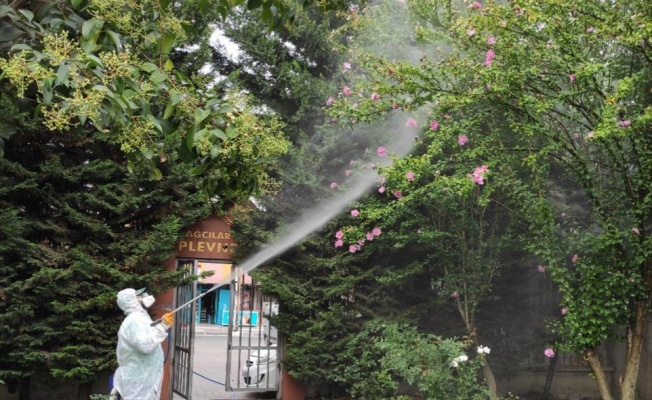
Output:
left=620, top=301, right=648, bottom=400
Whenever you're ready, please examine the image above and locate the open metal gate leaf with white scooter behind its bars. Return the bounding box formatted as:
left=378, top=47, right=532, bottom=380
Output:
left=225, top=276, right=281, bottom=392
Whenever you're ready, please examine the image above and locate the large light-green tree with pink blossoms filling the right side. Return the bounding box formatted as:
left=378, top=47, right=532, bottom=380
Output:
left=326, top=0, right=652, bottom=399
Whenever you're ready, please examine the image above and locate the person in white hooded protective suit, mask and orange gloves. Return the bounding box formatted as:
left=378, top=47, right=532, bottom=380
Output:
left=110, top=289, right=174, bottom=400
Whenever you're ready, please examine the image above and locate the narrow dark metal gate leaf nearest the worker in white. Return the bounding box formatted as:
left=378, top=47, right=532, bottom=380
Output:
left=172, top=260, right=197, bottom=400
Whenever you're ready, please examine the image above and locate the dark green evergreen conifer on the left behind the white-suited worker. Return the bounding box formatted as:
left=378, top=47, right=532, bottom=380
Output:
left=0, top=90, right=211, bottom=398
